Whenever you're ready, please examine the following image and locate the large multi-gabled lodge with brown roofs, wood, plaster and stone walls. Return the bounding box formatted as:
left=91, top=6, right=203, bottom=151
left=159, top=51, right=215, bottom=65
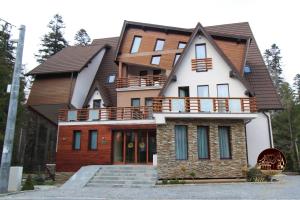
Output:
left=28, top=21, right=281, bottom=179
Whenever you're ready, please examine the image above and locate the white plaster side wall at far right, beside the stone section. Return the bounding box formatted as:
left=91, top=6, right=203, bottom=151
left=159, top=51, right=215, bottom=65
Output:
left=246, top=113, right=273, bottom=166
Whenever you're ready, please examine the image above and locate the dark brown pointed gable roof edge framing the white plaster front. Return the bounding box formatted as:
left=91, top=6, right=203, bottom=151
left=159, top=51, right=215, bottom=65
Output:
left=159, top=23, right=253, bottom=95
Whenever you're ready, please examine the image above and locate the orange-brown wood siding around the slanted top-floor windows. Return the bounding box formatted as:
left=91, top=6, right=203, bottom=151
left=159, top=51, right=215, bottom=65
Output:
left=118, top=28, right=189, bottom=69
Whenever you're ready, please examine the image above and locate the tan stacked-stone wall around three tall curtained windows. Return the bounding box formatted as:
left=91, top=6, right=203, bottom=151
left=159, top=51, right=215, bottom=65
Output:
left=157, top=119, right=247, bottom=179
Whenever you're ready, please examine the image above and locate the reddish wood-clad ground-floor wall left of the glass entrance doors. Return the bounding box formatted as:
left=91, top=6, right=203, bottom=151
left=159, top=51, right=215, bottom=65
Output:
left=56, top=125, right=112, bottom=171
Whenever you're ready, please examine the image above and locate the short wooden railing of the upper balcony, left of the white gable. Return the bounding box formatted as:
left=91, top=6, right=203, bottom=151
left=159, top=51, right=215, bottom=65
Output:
left=116, top=75, right=166, bottom=88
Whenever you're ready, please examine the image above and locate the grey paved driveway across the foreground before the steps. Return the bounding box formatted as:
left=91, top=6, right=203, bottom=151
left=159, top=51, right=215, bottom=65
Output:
left=0, top=176, right=300, bottom=200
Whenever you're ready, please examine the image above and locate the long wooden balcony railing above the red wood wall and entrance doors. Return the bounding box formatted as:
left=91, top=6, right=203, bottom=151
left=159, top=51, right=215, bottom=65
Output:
left=58, top=106, right=153, bottom=122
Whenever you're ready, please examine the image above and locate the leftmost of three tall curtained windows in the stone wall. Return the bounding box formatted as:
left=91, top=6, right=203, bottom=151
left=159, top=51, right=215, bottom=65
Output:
left=175, top=125, right=188, bottom=160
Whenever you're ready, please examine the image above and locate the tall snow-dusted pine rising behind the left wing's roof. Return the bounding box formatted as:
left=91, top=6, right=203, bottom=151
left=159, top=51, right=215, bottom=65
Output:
left=35, top=14, right=68, bottom=63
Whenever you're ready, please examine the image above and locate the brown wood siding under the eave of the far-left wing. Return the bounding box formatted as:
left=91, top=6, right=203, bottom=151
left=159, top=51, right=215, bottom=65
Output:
left=27, top=75, right=75, bottom=105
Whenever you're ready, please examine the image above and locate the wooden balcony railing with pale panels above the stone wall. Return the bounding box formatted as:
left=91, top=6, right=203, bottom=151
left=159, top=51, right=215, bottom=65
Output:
left=153, top=97, right=257, bottom=113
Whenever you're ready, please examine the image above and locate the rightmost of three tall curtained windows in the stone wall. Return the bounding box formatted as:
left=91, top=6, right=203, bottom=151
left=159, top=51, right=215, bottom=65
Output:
left=219, top=126, right=231, bottom=159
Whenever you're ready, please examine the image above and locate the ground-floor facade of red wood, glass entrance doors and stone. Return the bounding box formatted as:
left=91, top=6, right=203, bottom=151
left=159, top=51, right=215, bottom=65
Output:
left=56, top=119, right=251, bottom=179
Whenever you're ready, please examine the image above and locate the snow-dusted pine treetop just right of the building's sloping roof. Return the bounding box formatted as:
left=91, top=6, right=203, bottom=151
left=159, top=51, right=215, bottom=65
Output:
left=264, top=44, right=283, bottom=91
